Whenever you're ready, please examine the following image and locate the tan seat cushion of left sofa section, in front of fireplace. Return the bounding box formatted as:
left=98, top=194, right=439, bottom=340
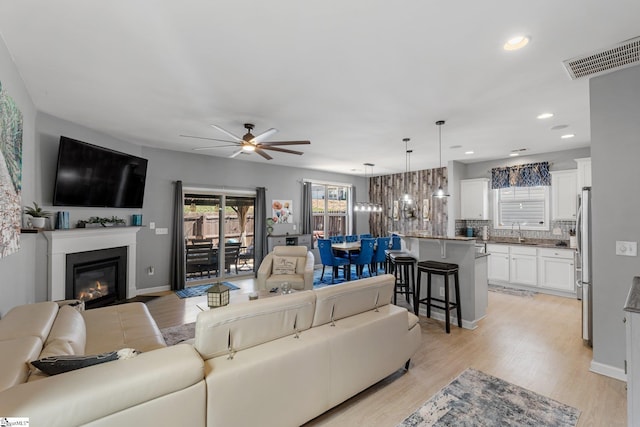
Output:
left=82, top=302, right=166, bottom=354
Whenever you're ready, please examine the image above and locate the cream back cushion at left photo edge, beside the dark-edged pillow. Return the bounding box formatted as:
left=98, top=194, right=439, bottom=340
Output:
left=0, top=336, right=42, bottom=391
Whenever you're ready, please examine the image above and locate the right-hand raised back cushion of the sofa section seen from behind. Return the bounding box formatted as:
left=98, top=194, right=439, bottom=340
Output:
left=313, top=274, right=395, bottom=327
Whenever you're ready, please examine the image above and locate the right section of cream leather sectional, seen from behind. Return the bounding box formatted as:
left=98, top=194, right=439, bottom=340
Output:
left=194, top=275, right=421, bottom=427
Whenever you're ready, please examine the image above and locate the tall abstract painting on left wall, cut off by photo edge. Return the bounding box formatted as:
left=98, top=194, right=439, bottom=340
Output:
left=0, top=82, right=22, bottom=258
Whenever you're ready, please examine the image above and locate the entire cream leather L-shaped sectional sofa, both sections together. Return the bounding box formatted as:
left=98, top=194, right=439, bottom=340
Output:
left=0, top=275, right=421, bottom=427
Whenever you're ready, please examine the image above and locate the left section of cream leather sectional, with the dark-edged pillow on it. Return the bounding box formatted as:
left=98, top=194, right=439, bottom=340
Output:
left=0, top=302, right=206, bottom=427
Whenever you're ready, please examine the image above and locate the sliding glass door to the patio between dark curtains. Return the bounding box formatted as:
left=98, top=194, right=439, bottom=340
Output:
left=184, top=189, right=255, bottom=286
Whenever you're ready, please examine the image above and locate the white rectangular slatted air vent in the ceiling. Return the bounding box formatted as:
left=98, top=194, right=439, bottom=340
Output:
left=563, top=37, right=640, bottom=80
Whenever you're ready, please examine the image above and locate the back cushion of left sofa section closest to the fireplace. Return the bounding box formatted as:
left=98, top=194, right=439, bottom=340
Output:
left=0, top=301, right=58, bottom=343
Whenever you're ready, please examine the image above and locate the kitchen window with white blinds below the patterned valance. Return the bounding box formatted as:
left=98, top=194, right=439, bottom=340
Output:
left=493, top=186, right=549, bottom=230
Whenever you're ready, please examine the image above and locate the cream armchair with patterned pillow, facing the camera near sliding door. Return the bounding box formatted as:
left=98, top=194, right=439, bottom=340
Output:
left=257, top=246, right=315, bottom=290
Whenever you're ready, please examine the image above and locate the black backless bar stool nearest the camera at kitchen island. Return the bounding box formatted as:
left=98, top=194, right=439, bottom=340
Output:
left=413, top=261, right=462, bottom=333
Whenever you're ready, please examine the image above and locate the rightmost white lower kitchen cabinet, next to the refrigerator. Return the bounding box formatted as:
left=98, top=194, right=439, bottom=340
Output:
left=538, top=248, right=575, bottom=293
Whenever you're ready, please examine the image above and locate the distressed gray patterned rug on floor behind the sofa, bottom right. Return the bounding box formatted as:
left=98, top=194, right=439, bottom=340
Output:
left=398, top=369, right=580, bottom=427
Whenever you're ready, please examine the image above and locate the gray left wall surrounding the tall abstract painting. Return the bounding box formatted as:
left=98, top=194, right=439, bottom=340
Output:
left=0, top=33, right=40, bottom=316
